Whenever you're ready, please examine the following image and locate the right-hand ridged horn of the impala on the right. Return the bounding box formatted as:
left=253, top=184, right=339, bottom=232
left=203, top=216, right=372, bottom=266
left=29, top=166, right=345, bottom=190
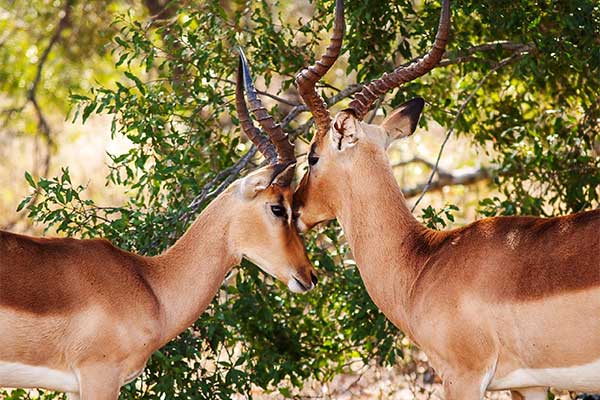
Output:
left=347, top=0, right=450, bottom=119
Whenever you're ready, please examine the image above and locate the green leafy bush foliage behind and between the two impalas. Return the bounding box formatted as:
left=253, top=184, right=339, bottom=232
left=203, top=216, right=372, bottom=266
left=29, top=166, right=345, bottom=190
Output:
left=12, top=0, right=600, bottom=399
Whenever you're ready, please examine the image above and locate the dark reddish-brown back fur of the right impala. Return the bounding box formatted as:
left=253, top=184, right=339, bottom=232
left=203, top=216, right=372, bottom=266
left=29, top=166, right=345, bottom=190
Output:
left=411, top=210, right=600, bottom=300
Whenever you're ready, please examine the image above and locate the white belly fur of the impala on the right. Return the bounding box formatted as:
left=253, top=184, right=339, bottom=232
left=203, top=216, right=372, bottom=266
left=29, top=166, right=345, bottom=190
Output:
left=488, top=360, right=600, bottom=391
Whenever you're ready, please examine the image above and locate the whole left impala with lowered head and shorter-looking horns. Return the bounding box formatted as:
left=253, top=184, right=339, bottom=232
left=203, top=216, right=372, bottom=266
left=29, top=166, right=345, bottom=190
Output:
left=0, top=51, right=317, bottom=400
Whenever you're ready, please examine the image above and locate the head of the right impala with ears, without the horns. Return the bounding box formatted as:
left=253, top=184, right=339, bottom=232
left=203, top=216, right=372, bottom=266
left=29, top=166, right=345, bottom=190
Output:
left=294, top=98, right=424, bottom=231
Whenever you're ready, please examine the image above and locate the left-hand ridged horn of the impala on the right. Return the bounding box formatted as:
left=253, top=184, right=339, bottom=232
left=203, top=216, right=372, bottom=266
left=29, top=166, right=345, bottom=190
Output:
left=296, top=0, right=344, bottom=139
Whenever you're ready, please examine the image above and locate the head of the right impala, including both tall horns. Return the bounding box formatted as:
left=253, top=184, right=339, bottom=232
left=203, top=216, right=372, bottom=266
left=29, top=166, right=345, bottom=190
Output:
left=294, top=0, right=450, bottom=230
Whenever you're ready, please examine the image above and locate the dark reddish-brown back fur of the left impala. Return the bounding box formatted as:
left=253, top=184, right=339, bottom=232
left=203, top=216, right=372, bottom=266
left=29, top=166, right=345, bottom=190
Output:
left=0, top=231, right=152, bottom=316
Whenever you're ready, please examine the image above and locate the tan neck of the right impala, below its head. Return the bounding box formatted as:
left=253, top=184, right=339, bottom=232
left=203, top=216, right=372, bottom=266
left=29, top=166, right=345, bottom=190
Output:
left=337, top=154, right=432, bottom=333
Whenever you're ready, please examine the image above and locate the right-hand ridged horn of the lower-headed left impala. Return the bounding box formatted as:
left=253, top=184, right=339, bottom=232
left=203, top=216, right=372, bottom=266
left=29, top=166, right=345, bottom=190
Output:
left=240, top=48, right=296, bottom=164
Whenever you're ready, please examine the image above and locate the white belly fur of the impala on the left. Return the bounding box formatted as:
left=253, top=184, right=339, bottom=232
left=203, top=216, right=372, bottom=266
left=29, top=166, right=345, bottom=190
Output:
left=0, top=361, right=79, bottom=393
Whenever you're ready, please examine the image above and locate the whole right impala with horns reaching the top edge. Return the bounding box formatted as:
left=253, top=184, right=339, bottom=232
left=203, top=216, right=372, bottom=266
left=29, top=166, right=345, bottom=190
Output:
left=294, top=0, right=600, bottom=400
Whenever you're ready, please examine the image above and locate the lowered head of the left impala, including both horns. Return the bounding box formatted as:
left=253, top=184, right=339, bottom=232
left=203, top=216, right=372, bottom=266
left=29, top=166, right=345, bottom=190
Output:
left=231, top=50, right=317, bottom=293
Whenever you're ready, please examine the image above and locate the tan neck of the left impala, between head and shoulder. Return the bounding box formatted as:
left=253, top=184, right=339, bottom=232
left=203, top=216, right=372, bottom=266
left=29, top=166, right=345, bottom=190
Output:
left=149, top=190, right=241, bottom=342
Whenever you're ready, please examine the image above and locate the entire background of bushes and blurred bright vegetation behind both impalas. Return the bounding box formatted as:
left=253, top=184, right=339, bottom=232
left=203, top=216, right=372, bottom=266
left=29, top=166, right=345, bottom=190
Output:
left=0, top=0, right=600, bottom=399
